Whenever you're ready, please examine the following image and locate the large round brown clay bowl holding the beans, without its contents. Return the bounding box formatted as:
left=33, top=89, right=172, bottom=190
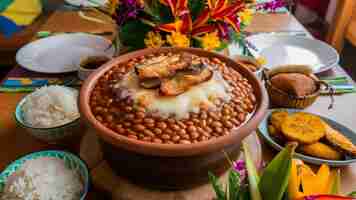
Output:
left=80, top=48, right=268, bottom=189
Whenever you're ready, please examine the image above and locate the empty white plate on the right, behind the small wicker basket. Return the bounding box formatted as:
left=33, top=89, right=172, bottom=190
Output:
left=246, top=33, right=340, bottom=73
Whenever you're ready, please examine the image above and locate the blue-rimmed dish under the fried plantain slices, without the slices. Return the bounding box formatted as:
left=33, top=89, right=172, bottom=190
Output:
left=258, top=109, right=356, bottom=167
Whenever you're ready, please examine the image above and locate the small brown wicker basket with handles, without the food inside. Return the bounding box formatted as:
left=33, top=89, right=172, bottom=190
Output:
left=263, top=71, right=332, bottom=109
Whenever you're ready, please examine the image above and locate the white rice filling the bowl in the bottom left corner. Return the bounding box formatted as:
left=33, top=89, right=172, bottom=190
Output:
left=0, top=157, right=83, bottom=200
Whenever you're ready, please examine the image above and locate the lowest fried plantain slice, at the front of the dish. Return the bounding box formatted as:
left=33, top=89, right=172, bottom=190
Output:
left=300, top=142, right=343, bottom=160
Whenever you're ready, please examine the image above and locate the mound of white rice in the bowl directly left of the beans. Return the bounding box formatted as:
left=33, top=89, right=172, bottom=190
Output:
left=22, top=86, right=79, bottom=128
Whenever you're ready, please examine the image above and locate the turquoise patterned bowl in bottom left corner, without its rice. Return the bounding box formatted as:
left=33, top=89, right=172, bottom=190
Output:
left=0, top=151, right=90, bottom=200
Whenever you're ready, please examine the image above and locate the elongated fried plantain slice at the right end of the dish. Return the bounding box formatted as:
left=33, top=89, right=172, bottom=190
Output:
left=324, top=123, right=356, bottom=156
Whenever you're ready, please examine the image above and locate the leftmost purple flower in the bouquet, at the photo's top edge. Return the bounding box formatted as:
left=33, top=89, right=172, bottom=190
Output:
left=116, top=0, right=143, bottom=26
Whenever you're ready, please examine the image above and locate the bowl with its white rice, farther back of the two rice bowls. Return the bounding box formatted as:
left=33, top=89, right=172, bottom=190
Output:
left=15, top=85, right=85, bottom=144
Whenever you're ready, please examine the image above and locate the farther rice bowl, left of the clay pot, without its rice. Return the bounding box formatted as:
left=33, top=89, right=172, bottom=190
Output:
left=15, top=90, right=83, bottom=144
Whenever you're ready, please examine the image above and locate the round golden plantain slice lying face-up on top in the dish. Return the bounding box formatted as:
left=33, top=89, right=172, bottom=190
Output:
left=282, top=112, right=325, bottom=144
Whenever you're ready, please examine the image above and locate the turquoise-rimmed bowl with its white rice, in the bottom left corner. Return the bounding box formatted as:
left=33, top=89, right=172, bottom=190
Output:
left=0, top=151, right=89, bottom=200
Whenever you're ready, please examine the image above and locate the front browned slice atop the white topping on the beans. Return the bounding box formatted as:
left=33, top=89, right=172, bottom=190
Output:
left=160, top=68, right=213, bottom=96
